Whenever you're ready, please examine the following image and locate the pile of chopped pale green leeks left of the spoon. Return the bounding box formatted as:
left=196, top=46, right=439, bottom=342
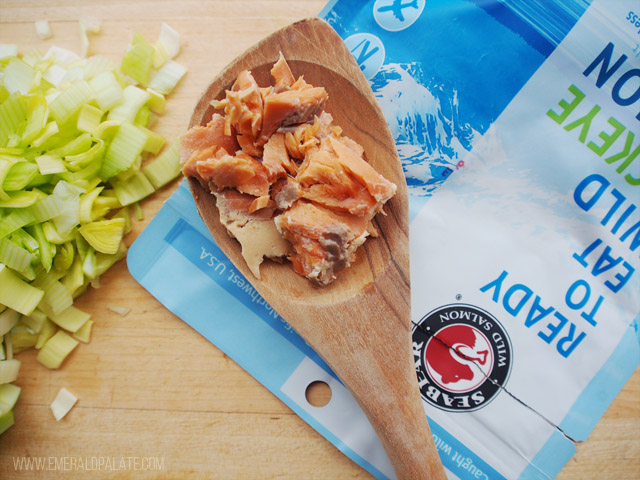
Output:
left=0, top=26, right=186, bottom=434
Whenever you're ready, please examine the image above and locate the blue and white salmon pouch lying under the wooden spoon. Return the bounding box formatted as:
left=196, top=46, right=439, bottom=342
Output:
left=128, top=0, right=640, bottom=480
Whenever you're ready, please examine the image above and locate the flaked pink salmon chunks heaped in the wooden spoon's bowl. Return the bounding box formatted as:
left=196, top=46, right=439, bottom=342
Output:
left=180, top=54, right=396, bottom=285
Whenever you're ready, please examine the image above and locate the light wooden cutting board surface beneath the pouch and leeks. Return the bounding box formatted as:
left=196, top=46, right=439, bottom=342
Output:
left=0, top=0, right=640, bottom=480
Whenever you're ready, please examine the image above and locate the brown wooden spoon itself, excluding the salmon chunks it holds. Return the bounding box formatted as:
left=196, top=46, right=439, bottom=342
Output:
left=189, top=19, right=446, bottom=480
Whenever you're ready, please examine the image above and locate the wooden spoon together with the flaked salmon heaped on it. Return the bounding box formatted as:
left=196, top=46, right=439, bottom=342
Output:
left=182, top=19, right=446, bottom=480
